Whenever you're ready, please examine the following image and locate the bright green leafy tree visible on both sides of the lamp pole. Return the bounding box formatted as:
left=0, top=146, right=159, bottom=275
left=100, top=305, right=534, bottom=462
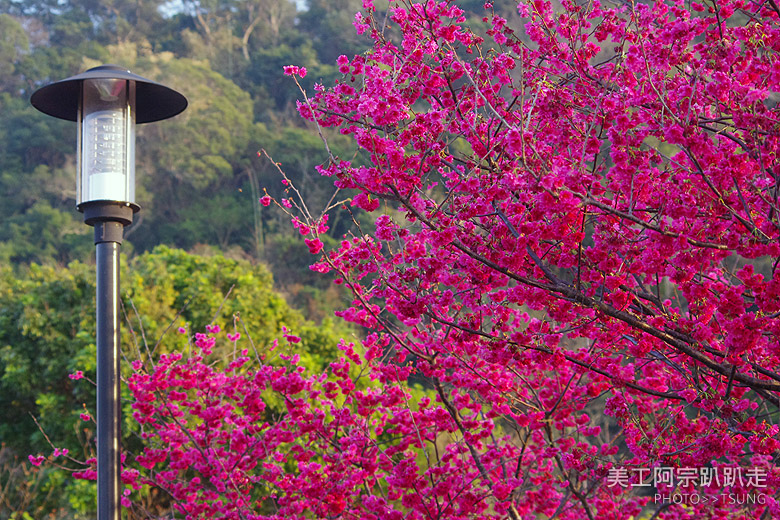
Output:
left=0, top=247, right=344, bottom=451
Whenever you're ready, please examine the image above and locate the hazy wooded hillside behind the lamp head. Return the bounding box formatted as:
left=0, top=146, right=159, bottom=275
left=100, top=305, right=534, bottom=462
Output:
left=0, top=0, right=378, bottom=264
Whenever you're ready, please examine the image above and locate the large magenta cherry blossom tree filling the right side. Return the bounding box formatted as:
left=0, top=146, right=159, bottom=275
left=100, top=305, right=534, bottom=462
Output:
left=288, top=0, right=780, bottom=518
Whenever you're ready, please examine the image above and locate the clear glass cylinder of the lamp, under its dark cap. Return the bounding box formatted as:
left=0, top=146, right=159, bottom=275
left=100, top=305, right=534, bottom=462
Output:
left=78, top=79, right=136, bottom=205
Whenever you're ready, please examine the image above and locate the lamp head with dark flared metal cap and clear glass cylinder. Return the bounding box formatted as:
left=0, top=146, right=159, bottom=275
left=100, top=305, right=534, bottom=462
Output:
left=30, top=65, right=187, bottom=211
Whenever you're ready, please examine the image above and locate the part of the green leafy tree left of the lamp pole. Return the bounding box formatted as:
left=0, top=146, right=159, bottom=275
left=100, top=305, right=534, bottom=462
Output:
left=0, top=263, right=95, bottom=453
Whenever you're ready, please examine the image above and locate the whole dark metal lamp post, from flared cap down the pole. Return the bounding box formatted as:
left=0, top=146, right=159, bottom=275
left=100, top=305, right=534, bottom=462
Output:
left=30, top=65, right=187, bottom=520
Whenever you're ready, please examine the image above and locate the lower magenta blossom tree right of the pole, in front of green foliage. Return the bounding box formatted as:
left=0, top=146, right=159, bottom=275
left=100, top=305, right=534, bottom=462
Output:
left=70, top=327, right=556, bottom=520
